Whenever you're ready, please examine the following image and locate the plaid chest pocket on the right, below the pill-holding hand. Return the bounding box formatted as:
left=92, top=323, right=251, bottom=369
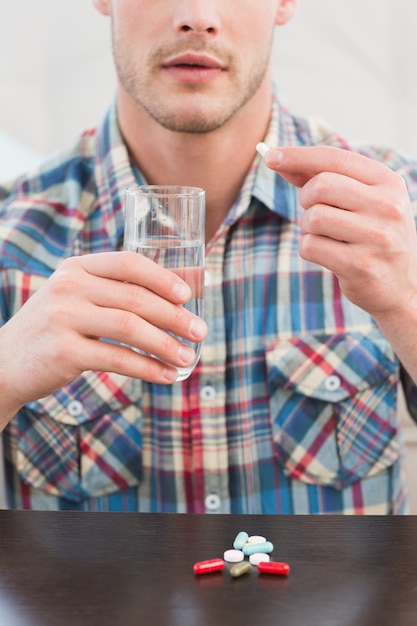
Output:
left=267, top=330, right=399, bottom=489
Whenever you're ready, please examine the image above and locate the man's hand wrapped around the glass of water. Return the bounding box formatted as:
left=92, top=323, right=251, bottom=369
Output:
left=0, top=252, right=207, bottom=427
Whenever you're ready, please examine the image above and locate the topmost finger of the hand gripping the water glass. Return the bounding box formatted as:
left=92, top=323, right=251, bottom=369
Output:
left=68, top=251, right=191, bottom=303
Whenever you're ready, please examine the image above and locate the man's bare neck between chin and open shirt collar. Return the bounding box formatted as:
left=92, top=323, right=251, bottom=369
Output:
left=118, top=79, right=271, bottom=241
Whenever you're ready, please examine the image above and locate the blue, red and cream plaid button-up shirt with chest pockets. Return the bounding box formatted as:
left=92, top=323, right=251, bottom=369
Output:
left=0, top=92, right=417, bottom=514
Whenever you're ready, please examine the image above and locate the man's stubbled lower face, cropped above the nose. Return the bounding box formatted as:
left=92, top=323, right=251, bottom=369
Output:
left=105, top=0, right=281, bottom=133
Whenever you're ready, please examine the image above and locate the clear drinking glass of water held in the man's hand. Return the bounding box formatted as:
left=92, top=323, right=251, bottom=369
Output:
left=124, top=185, right=205, bottom=381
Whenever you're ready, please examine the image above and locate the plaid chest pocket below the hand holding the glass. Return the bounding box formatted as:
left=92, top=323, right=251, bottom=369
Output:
left=16, top=372, right=142, bottom=502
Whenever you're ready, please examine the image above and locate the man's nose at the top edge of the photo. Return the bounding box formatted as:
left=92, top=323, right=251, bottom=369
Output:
left=174, top=0, right=220, bottom=35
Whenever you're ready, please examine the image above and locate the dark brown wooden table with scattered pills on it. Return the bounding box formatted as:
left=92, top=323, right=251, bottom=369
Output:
left=0, top=511, right=417, bottom=626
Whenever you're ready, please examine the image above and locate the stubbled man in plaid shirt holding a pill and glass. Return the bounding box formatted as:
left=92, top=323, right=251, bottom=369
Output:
left=0, top=0, right=417, bottom=513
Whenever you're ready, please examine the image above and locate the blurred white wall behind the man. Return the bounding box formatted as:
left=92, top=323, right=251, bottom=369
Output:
left=0, top=0, right=417, bottom=513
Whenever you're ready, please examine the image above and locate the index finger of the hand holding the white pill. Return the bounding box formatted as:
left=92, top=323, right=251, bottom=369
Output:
left=265, top=146, right=391, bottom=187
